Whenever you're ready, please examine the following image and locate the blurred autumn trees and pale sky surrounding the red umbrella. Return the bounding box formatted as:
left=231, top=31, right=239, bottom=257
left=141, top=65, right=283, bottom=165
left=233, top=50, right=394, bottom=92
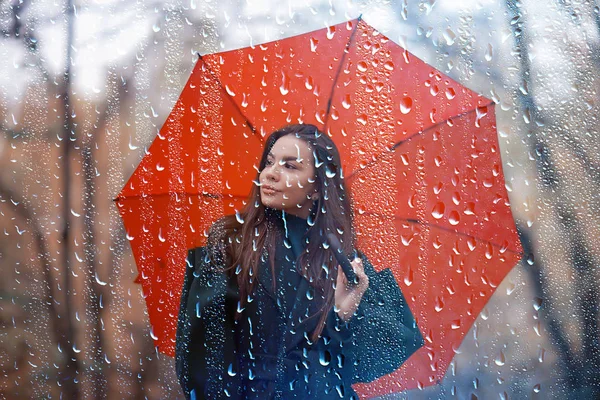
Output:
left=0, top=0, right=600, bottom=400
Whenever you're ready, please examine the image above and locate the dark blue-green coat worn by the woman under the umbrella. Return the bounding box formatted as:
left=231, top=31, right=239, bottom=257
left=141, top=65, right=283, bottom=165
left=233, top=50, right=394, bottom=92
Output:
left=176, top=219, right=423, bottom=399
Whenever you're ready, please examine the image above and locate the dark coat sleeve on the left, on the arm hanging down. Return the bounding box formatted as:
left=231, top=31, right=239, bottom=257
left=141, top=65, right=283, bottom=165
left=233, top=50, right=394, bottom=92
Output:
left=175, top=247, right=241, bottom=399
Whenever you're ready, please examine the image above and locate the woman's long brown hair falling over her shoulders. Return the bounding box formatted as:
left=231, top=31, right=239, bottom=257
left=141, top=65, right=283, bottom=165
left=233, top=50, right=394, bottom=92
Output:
left=209, top=124, right=354, bottom=341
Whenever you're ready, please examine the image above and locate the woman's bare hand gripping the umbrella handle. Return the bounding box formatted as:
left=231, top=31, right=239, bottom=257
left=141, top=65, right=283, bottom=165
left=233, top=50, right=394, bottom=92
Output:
left=335, top=258, right=369, bottom=321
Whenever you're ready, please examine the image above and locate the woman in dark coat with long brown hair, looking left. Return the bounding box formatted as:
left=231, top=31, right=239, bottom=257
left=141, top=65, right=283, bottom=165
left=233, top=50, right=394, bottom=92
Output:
left=176, top=124, right=422, bottom=399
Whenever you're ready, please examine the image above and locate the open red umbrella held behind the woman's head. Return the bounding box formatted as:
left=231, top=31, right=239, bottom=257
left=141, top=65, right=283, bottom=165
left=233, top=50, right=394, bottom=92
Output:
left=117, top=19, right=522, bottom=396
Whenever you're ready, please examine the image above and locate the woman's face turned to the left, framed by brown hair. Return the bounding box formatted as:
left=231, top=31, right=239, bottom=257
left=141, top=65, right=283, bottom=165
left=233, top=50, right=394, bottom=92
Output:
left=260, top=135, right=318, bottom=218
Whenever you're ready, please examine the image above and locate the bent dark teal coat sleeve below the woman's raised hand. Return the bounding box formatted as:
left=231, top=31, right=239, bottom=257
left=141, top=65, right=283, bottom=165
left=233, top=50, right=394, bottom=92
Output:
left=348, top=255, right=423, bottom=383
